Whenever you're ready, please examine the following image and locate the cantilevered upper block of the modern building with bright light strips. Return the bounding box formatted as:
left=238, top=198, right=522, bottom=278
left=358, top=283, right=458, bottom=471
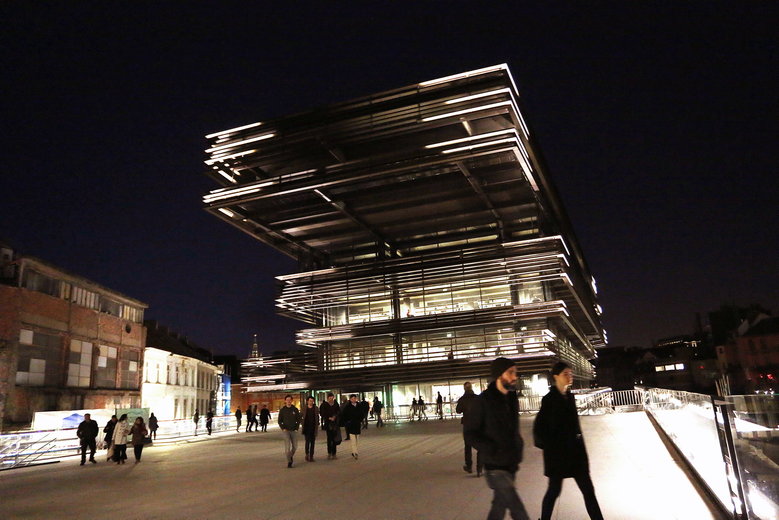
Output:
left=204, top=65, right=576, bottom=265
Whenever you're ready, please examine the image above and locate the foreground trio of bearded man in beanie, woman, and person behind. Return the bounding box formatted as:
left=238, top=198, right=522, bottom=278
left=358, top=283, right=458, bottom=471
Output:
left=457, top=357, right=603, bottom=520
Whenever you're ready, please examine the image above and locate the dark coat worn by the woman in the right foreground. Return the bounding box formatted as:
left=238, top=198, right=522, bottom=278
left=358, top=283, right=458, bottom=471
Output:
left=533, top=386, right=589, bottom=478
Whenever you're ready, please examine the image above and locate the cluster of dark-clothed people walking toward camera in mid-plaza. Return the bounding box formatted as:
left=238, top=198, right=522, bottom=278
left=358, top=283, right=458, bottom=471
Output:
left=278, top=392, right=384, bottom=468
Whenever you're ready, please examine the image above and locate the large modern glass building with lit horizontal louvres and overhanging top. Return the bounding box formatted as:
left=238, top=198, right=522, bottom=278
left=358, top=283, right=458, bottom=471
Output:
left=203, top=65, right=606, bottom=407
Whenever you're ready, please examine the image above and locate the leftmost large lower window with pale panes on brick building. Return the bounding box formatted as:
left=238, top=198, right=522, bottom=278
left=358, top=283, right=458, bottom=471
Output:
left=16, top=329, right=62, bottom=386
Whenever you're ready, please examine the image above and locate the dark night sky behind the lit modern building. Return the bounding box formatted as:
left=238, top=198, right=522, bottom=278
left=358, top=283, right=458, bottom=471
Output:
left=0, top=1, right=779, bottom=355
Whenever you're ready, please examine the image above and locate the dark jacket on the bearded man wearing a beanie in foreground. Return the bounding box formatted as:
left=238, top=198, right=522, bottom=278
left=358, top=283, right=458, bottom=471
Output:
left=463, top=381, right=524, bottom=472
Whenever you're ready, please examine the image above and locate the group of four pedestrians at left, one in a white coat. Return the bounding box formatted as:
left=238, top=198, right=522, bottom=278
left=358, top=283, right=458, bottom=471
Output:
left=76, top=413, right=159, bottom=466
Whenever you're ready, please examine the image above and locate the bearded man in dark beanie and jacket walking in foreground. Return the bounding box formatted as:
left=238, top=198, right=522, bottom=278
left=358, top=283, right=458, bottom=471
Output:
left=464, top=357, right=529, bottom=520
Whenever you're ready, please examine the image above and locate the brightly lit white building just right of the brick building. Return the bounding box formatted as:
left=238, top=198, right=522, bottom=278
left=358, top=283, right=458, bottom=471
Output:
left=141, top=321, right=218, bottom=420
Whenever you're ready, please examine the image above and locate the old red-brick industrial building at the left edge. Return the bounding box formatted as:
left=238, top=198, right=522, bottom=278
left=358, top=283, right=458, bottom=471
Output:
left=0, top=244, right=147, bottom=428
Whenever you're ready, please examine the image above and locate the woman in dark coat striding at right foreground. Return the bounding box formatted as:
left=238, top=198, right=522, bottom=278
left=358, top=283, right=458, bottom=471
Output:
left=533, top=361, right=603, bottom=520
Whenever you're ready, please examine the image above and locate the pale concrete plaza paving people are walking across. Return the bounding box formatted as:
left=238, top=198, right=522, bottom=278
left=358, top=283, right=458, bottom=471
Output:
left=0, top=412, right=720, bottom=520
